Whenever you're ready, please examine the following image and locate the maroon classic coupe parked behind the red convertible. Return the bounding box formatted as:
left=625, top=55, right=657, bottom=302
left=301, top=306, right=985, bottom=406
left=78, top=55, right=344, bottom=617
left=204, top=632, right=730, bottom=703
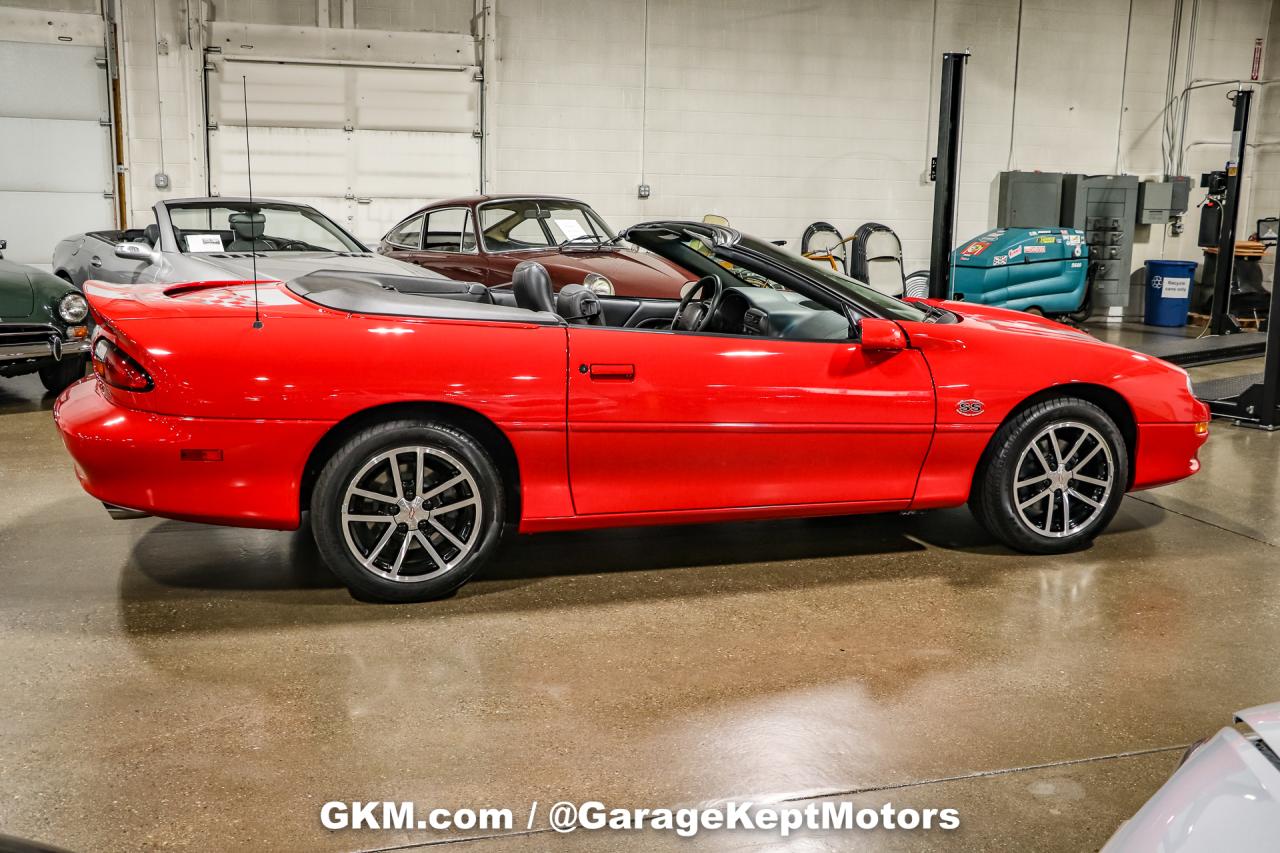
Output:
left=378, top=196, right=689, bottom=298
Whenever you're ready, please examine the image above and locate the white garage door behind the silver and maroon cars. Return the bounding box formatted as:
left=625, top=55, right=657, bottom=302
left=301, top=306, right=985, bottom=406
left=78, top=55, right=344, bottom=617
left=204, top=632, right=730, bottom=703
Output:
left=209, top=55, right=480, bottom=243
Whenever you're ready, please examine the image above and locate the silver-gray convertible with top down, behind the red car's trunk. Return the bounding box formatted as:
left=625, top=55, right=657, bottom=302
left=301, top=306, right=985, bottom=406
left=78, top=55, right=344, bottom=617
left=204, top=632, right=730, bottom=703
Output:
left=52, top=199, right=465, bottom=287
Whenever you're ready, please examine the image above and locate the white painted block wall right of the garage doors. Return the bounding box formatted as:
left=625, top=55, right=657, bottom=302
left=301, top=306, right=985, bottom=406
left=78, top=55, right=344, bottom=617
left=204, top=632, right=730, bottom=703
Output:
left=490, top=0, right=1271, bottom=281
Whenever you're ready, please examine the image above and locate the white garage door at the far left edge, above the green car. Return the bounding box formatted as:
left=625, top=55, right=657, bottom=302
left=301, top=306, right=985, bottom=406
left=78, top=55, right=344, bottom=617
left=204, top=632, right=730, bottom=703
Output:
left=0, top=41, right=115, bottom=268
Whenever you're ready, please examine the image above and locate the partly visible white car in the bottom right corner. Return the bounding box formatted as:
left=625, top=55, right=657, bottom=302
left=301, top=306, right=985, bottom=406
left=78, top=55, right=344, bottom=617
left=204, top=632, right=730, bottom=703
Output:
left=1102, top=702, right=1280, bottom=853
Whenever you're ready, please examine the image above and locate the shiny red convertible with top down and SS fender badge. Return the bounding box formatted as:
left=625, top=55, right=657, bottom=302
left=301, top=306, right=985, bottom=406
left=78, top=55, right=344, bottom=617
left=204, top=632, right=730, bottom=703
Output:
left=54, top=222, right=1208, bottom=601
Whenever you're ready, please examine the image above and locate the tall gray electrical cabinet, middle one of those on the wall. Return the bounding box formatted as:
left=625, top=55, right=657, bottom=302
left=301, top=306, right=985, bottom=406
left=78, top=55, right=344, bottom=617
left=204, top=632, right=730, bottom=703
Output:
left=1059, top=174, right=1138, bottom=309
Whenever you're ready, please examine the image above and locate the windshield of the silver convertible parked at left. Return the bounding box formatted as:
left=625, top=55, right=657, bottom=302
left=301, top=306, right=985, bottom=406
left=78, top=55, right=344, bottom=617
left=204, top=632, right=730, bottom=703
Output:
left=168, top=201, right=366, bottom=252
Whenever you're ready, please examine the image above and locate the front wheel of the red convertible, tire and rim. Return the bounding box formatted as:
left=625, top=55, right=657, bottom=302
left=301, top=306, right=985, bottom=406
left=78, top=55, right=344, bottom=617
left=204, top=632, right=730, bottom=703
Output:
left=969, top=397, right=1129, bottom=553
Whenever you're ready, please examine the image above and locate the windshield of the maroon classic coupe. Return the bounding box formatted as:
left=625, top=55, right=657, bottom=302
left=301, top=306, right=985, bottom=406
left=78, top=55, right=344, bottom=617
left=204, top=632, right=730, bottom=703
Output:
left=480, top=199, right=616, bottom=252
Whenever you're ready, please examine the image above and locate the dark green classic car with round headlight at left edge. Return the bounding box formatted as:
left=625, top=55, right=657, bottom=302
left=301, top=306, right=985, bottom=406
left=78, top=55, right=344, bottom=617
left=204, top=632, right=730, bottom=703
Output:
left=0, top=241, right=90, bottom=393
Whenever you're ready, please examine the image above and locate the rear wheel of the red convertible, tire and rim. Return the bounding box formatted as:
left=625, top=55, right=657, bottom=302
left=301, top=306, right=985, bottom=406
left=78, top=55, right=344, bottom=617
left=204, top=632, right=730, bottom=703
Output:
left=311, top=420, right=506, bottom=602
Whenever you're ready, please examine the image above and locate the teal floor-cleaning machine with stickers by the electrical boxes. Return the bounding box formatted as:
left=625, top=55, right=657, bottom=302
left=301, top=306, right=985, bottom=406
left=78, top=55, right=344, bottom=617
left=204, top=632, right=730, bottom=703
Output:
left=951, top=228, right=1091, bottom=316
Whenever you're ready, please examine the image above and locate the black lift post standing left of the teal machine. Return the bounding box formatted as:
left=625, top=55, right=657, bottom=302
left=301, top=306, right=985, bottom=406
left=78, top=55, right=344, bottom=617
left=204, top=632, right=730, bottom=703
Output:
left=929, top=51, right=969, bottom=300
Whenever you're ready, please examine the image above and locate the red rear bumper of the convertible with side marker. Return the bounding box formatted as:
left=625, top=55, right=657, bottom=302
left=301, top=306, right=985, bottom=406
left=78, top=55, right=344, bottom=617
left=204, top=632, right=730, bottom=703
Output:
left=54, top=379, right=330, bottom=530
